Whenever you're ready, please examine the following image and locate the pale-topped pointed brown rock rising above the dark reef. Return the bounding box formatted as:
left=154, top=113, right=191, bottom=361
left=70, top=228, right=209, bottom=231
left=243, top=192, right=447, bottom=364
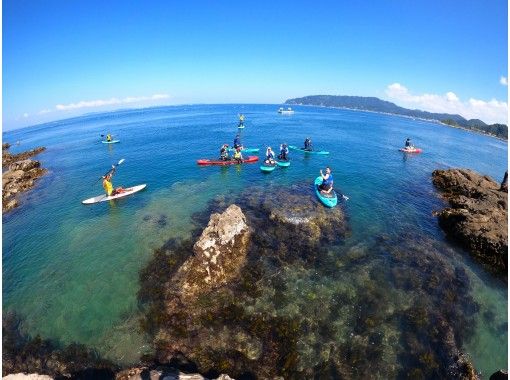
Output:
left=175, top=205, right=250, bottom=297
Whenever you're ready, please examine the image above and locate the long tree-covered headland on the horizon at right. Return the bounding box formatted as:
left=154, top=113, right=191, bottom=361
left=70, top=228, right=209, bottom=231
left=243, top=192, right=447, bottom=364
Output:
left=285, top=95, right=508, bottom=140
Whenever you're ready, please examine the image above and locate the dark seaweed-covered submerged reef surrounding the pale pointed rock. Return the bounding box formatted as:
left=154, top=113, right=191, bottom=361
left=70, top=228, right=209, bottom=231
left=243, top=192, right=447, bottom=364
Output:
left=139, top=185, right=479, bottom=379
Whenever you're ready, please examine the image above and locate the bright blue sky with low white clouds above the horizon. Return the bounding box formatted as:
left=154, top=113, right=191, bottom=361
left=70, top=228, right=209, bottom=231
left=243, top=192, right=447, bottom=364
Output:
left=2, top=0, right=508, bottom=129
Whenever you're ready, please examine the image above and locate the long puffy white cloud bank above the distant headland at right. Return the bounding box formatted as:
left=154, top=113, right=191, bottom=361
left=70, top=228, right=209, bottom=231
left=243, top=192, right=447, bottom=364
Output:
left=386, top=83, right=508, bottom=124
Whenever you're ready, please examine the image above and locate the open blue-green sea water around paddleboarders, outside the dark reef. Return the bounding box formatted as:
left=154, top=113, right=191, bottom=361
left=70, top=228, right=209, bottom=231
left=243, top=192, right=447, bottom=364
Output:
left=3, top=105, right=507, bottom=374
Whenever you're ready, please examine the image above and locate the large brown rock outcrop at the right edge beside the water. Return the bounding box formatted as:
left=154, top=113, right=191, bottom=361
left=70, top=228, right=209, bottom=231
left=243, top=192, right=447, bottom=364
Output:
left=432, top=169, right=508, bottom=274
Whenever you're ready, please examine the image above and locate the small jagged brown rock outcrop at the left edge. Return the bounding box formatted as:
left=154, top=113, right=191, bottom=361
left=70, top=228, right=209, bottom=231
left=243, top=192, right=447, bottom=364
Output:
left=2, top=143, right=48, bottom=213
